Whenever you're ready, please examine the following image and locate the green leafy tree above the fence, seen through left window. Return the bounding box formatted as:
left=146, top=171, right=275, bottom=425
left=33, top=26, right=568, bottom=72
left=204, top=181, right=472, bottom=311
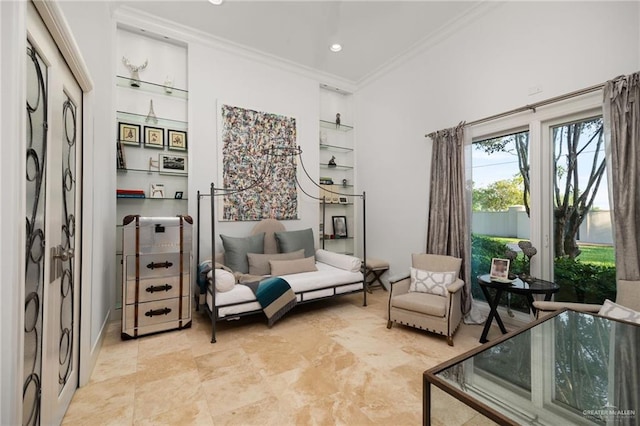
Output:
left=473, top=175, right=524, bottom=212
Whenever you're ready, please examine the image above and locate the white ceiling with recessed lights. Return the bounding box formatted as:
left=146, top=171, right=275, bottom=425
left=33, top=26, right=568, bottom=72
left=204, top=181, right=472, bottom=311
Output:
left=113, top=0, right=480, bottom=84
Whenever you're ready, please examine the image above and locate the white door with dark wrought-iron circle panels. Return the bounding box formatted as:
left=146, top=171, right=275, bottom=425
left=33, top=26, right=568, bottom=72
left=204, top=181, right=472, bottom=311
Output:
left=22, top=3, right=82, bottom=425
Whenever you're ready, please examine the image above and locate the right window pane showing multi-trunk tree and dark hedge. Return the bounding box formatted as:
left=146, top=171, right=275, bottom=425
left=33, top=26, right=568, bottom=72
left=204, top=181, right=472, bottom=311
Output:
left=551, top=117, right=616, bottom=303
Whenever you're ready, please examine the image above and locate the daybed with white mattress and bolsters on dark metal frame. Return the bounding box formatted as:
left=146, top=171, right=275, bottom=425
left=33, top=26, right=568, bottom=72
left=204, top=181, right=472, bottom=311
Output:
left=199, top=219, right=367, bottom=343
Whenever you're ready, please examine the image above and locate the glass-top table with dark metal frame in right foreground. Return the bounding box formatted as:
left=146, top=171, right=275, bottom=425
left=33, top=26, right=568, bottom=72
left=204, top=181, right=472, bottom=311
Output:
left=423, top=310, right=640, bottom=425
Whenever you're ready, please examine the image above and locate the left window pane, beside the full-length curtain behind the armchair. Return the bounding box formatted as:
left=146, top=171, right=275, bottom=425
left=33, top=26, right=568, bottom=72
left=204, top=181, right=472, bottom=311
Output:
left=471, top=131, right=531, bottom=312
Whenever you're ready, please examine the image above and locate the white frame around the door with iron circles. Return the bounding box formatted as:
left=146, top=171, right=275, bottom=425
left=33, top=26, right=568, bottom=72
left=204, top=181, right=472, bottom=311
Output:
left=0, top=1, right=93, bottom=424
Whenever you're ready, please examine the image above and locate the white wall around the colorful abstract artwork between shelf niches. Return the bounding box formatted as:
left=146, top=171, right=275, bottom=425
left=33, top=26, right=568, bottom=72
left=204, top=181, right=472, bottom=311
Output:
left=188, top=42, right=320, bottom=258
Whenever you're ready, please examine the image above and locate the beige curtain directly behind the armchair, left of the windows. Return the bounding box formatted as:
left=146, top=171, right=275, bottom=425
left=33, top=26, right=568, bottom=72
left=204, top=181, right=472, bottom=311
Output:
left=427, top=123, right=472, bottom=315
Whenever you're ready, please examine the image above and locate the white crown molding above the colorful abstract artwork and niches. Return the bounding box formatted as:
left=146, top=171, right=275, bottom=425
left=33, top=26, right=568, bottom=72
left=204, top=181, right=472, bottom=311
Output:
left=113, top=6, right=357, bottom=93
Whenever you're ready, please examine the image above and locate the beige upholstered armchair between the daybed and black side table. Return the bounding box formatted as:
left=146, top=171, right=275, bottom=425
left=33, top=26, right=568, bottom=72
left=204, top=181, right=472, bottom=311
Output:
left=387, top=254, right=464, bottom=346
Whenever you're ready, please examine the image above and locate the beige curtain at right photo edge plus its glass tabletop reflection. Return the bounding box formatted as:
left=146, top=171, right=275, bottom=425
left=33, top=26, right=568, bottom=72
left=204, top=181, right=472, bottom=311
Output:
left=603, top=73, right=640, bottom=425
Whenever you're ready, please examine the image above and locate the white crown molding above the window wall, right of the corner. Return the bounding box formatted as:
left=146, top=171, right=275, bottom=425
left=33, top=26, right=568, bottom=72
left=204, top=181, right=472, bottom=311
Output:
left=356, top=0, right=502, bottom=89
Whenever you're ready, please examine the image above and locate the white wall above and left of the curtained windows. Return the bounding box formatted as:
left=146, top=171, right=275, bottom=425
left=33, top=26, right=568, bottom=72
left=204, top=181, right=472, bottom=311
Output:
left=355, top=2, right=640, bottom=282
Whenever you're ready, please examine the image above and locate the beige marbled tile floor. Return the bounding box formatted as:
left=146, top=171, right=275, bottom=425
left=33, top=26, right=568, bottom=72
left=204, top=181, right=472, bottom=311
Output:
left=63, top=289, right=499, bottom=426
